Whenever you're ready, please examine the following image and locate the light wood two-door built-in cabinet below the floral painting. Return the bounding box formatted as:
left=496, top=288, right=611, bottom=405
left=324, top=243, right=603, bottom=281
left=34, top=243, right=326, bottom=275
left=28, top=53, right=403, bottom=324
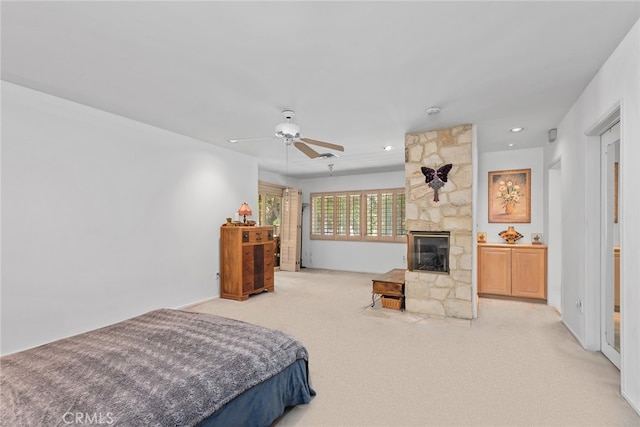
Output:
left=478, top=243, right=547, bottom=300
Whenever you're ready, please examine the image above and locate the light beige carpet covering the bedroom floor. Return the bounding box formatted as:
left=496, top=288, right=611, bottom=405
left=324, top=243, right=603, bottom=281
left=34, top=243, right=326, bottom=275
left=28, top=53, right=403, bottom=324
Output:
left=191, top=269, right=640, bottom=427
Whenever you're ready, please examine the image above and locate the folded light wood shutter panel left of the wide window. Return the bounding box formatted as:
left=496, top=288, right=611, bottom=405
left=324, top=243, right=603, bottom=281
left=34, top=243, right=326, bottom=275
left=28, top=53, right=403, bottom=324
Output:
left=280, top=188, right=302, bottom=271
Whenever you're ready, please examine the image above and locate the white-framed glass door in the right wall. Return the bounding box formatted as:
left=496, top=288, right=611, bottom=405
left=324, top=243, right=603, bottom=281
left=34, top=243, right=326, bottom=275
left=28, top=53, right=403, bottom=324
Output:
left=600, top=120, right=622, bottom=369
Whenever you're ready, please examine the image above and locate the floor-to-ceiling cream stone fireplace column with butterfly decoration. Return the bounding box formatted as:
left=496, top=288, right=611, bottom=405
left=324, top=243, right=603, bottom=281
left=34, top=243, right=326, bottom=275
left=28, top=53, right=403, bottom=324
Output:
left=404, top=124, right=473, bottom=319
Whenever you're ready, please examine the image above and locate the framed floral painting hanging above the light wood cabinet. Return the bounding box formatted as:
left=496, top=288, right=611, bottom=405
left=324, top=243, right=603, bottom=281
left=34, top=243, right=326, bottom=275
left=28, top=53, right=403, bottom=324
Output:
left=489, top=169, right=531, bottom=223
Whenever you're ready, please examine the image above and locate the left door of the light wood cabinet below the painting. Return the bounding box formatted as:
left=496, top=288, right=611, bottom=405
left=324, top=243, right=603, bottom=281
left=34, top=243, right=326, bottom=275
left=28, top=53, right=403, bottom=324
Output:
left=478, top=246, right=511, bottom=295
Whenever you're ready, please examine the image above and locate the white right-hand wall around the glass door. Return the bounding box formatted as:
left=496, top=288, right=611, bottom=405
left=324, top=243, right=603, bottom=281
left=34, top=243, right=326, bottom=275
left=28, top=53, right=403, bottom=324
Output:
left=545, top=21, right=640, bottom=413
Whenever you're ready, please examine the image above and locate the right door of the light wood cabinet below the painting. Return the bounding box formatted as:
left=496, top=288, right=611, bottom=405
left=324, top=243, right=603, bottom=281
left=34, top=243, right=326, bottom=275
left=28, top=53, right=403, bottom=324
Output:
left=511, top=248, right=547, bottom=299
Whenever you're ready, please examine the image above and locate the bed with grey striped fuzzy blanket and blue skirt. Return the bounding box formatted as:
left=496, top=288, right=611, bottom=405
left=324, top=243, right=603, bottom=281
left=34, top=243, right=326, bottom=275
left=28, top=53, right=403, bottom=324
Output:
left=0, top=309, right=315, bottom=427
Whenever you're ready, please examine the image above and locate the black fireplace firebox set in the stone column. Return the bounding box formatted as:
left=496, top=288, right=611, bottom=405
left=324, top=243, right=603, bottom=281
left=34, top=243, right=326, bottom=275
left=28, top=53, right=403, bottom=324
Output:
left=407, top=231, right=450, bottom=274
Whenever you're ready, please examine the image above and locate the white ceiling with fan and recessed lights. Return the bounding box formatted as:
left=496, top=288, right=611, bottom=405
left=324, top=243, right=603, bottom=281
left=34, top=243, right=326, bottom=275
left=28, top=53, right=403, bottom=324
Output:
left=1, top=1, right=640, bottom=177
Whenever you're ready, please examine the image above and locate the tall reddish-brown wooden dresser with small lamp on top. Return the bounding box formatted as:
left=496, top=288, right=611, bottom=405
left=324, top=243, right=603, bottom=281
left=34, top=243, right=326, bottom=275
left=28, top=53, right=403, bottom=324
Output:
left=220, top=226, right=275, bottom=301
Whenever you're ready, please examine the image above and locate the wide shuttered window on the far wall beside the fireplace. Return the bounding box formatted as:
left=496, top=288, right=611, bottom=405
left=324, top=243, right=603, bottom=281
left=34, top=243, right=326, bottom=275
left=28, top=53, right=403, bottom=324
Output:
left=311, top=188, right=406, bottom=242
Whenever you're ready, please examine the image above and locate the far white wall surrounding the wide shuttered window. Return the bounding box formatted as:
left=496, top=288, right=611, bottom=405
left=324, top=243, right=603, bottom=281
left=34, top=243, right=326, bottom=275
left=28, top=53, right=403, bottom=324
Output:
left=299, top=169, right=407, bottom=273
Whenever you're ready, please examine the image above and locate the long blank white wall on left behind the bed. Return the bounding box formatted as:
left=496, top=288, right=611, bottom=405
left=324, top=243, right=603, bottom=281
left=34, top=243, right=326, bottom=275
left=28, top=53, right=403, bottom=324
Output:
left=1, top=82, right=258, bottom=354
